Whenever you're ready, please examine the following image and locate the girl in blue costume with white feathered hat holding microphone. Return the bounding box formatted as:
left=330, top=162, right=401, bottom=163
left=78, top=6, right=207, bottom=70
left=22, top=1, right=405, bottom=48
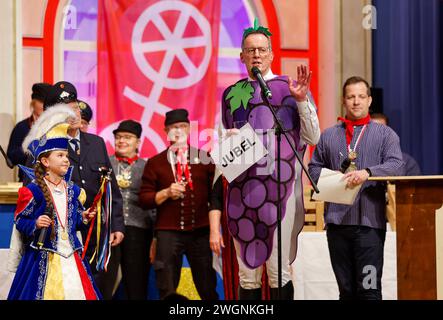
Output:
left=8, top=106, right=101, bottom=300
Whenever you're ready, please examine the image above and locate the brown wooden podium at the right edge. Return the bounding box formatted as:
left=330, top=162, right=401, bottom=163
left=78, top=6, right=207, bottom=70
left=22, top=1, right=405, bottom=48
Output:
left=369, top=176, right=443, bottom=300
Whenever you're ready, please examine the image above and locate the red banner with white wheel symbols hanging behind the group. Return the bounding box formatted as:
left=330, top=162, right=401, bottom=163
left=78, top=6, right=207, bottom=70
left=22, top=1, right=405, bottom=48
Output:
left=97, top=0, right=220, bottom=157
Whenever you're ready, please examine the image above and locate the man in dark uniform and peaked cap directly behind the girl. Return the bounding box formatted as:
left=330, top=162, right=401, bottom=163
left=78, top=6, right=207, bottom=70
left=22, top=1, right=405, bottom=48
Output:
left=23, top=81, right=125, bottom=300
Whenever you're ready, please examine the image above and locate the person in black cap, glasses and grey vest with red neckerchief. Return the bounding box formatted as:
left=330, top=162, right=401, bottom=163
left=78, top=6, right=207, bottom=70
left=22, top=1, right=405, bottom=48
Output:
left=110, top=120, right=155, bottom=300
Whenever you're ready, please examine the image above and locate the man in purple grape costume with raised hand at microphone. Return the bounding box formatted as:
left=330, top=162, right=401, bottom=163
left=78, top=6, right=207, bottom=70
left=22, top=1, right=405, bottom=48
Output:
left=221, top=20, right=320, bottom=300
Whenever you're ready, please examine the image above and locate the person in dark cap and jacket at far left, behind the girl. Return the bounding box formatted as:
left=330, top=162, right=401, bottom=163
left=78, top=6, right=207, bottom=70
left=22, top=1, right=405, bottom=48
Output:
left=7, top=82, right=51, bottom=181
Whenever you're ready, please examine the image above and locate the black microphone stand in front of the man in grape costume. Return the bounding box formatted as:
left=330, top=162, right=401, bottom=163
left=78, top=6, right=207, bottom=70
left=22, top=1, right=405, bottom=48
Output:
left=259, top=82, right=320, bottom=300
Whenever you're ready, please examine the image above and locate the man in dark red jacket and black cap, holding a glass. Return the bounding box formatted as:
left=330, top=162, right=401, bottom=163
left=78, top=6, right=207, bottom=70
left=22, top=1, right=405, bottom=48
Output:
left=140, top=109, right=218, bottom=300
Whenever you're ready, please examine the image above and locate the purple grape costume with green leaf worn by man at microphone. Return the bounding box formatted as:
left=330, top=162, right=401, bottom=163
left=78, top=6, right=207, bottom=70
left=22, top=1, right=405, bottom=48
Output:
left=221, top=76, right=318, bottom=269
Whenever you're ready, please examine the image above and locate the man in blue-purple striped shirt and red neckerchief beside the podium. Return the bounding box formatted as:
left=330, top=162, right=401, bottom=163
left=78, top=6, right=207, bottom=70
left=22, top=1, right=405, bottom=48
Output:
left=309, top=77, right=404, bottom=300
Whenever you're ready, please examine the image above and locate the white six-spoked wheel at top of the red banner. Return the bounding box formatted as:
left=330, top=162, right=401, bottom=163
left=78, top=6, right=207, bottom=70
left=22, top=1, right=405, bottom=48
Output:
left=132, top=1, right=212, bottom=89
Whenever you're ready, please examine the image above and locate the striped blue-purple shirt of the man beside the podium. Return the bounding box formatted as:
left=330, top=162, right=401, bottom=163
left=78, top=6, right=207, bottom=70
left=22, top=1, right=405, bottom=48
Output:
left=309, top=121, right=404, bottom=230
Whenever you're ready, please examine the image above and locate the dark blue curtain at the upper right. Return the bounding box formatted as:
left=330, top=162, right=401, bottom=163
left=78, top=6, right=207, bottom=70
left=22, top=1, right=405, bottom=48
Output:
left=372, top=0, right=443, bottom=174
